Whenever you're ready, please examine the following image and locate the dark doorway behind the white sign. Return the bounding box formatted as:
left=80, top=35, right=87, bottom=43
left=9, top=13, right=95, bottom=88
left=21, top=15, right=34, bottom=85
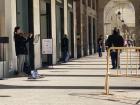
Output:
left=40, top=0, right=52, bottom=67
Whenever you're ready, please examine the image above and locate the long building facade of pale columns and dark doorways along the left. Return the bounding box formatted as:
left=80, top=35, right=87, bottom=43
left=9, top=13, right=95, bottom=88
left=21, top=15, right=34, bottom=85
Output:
left=0, top=0, right=97, bottom=77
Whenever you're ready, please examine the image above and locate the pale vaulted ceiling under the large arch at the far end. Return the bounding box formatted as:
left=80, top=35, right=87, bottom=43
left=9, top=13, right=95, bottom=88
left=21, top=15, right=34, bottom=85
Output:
left=104, top=0, right=135, bottom=27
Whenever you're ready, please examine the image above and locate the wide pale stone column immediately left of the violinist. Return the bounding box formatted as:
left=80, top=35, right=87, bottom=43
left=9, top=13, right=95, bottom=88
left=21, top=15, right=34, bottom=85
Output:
left=4, top=0, right=17, bottom=70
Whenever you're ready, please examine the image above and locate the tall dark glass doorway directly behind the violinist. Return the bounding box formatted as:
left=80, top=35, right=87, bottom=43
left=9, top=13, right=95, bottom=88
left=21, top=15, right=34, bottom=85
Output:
left=16, top=0, right=34, bottom=69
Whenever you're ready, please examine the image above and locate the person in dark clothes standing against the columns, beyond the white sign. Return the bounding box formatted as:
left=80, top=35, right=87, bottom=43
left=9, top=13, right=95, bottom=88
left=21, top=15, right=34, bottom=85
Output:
left=62, top=35, right=69, bottom=62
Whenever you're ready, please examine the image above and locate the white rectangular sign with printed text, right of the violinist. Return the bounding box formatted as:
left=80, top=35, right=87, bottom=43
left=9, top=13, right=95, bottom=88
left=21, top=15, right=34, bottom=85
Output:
left=42, top=39, right=53, bottom=54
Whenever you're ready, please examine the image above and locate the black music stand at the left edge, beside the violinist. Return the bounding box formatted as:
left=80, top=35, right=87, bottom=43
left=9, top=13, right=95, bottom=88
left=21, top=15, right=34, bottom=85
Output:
left=0, top=37, right=9, bottom=80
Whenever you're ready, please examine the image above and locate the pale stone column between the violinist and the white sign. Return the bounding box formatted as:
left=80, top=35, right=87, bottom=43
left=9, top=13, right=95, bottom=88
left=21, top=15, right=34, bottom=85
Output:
left=33, top=0, right=41, bottom=68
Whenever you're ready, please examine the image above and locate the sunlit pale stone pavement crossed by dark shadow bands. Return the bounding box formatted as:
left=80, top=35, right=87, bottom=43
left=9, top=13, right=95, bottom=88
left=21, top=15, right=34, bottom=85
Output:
left=0, top=54, right=140, bottom=105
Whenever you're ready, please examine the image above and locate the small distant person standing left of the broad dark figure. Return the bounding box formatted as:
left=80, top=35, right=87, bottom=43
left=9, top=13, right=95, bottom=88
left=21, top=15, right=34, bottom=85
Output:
left=97, top=35, right=103, bottom=57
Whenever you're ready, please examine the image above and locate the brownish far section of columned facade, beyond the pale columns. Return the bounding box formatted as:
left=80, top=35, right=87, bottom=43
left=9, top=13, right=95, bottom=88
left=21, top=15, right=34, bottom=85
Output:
left=76, top=0, right=97, bottom=58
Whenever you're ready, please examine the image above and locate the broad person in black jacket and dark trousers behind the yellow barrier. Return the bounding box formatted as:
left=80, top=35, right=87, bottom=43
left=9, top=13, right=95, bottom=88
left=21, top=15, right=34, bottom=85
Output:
left=107, top=28, right=124, bottom=69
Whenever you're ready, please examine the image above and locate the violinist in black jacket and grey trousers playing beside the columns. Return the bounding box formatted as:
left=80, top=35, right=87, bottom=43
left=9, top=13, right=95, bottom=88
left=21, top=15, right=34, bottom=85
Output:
left=14, top=26, right=32, bottom=74
